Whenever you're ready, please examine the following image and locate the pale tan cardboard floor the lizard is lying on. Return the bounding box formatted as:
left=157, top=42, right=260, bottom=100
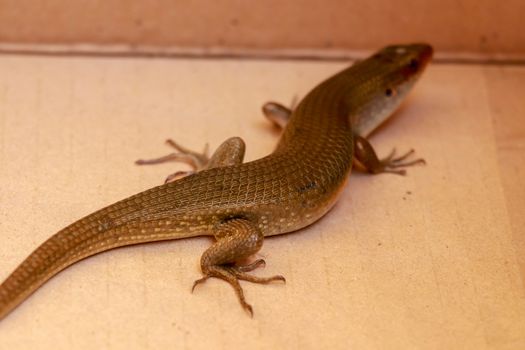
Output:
left=0, top=55, right=525, bottom=349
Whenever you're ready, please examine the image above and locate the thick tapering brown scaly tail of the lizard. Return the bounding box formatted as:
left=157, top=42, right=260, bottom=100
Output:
left=0, top=197, right=196, bottom=320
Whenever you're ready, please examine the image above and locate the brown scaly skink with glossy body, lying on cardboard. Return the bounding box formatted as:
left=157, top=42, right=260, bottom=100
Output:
left=0, top=43, right=433, bottom=320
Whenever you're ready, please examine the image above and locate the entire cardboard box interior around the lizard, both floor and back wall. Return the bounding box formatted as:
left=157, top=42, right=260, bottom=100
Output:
left=0, top=0, right=525, bottom=350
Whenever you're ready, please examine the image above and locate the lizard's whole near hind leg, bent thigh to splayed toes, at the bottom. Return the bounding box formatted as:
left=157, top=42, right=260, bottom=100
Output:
left=192, top=219, right=285, bottom=316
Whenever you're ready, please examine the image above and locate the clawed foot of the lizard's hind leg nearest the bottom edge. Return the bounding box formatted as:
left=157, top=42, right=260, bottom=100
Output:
left=191, top=259, right=286, bottom=317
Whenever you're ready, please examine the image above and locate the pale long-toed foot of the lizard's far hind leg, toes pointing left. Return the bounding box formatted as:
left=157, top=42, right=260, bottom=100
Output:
left=135, top=139, right=210, bottom=183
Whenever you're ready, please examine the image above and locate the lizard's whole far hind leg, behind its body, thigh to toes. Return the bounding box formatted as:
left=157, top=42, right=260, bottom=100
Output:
left=135, top=137, right=246, bottom=183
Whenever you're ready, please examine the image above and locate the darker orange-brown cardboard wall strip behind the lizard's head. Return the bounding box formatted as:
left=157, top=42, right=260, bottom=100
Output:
left=0, top=0, right=525, bottom=58
